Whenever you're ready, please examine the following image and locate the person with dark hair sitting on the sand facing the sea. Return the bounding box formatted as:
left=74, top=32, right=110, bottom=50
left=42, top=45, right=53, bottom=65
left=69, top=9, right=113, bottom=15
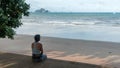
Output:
left=31, top=34, right=47, bottom=61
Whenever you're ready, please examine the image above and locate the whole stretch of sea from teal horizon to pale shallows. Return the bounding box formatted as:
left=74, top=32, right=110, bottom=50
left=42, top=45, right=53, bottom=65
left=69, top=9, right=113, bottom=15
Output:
left=16, top=13, right=120, bottom=42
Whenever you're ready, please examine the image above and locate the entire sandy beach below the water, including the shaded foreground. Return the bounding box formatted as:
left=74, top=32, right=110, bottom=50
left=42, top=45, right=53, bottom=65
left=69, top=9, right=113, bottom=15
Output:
left=0, top=35, right=120, bottom=68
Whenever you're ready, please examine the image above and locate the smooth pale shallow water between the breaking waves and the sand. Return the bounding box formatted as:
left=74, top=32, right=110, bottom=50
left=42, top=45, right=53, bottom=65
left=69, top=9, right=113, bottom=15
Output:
left=16, top=21, right=120, bottom=42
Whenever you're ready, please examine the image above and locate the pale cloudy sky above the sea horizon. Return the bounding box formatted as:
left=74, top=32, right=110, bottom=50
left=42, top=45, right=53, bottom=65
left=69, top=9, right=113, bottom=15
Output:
left=26, top=0, right=120, bottom=12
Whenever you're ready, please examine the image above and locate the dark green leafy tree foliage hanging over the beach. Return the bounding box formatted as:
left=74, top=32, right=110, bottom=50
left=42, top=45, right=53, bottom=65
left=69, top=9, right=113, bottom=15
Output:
left=0, top=0, right=30, bottom=39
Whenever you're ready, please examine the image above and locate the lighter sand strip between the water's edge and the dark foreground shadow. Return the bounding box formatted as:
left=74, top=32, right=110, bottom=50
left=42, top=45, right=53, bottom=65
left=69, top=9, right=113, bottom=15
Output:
left=0, top=35, right=120, bottom=68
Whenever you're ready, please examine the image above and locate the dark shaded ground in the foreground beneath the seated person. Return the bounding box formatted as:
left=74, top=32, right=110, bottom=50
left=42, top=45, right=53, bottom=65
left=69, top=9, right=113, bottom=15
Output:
left=0, top=53, right=101, bottom=68
